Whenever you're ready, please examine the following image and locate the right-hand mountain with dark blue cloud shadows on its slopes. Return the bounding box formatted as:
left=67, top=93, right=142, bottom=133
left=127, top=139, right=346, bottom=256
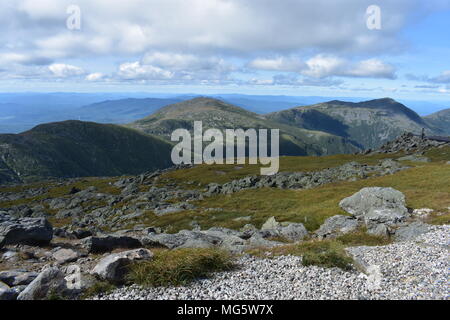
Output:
left=265, top=98, right=438, bottom=149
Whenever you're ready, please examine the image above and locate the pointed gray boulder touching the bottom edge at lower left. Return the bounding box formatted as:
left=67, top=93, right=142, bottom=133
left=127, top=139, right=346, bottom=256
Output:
left=17, top=267, right=67, bottom=300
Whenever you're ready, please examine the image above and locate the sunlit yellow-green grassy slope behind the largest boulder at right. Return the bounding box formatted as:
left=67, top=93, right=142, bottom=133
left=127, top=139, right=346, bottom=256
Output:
left=167, top=163, right=450, bottom=232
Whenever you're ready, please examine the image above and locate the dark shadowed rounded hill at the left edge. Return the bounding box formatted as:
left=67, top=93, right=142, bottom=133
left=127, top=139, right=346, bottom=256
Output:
left=0, top=121, right=172, bottom=183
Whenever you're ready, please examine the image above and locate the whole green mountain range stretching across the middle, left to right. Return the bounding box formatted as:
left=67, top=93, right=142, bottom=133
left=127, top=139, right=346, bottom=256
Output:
left=0, top=97, right=450, bottom=184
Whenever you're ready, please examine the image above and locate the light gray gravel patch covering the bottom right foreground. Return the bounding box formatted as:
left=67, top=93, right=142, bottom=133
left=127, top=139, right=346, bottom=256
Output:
left=94, top=226, right=450, bottom=300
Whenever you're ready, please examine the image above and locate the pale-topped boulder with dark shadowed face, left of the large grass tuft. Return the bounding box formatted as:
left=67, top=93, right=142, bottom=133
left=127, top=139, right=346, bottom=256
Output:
left=91, top=248, right=153, bottom=283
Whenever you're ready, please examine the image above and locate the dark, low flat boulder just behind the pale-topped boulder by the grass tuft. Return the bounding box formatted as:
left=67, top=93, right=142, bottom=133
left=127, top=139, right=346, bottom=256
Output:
left=81, top=235, right=142, bottom=253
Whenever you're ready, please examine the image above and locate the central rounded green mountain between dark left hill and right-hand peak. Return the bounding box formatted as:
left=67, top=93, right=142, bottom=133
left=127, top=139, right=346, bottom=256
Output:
left=128, top=98, right=358, bottom=155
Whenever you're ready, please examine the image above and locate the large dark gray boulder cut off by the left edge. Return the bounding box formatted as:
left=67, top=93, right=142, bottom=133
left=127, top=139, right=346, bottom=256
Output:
left=0, top=214, right=53, bottom=247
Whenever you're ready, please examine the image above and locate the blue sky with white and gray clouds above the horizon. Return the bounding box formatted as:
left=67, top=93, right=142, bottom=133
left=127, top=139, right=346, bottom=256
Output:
left=0, top=0, right=450, bottom=101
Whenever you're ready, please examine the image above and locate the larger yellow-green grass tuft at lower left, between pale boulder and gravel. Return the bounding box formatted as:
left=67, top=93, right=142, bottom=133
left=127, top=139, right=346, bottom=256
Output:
left=128, top=249, right=234, bottom=287
